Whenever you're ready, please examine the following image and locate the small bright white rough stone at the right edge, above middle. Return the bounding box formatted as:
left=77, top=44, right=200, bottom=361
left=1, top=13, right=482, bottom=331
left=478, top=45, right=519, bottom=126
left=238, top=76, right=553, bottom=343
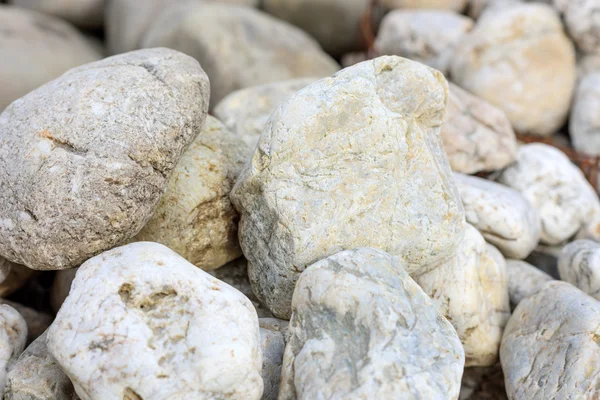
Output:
left=499, top=143, right=600, bottom=245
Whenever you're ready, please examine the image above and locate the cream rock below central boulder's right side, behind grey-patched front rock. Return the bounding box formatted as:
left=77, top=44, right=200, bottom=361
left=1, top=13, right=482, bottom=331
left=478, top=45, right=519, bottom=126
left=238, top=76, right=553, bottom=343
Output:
left=415, top=225, right=510, bottom=366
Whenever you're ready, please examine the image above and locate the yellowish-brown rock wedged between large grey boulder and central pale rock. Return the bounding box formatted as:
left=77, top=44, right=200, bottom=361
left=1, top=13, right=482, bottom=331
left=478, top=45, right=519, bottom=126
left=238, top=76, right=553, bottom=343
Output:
left=131, top=116, right=250, bottom=270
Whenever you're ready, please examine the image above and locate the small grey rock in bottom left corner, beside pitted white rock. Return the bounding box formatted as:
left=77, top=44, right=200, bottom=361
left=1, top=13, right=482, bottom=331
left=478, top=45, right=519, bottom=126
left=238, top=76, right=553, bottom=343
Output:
left=4, top=332, right=79, bottom=400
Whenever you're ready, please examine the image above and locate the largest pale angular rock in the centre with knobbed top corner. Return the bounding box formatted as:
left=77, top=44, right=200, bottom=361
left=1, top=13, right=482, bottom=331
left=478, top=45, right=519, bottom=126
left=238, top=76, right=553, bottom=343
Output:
left=231, top=57, right=464, bottom=319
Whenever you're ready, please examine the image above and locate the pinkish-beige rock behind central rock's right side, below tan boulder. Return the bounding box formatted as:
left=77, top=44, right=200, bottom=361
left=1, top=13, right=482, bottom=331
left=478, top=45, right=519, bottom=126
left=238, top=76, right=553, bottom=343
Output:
left=442, top=83, right=517, bottom=174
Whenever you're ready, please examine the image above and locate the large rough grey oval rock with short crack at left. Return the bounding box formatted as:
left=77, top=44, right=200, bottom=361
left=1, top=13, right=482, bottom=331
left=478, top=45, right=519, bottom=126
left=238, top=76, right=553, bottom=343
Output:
left=0, top=49, right=209, bottom=269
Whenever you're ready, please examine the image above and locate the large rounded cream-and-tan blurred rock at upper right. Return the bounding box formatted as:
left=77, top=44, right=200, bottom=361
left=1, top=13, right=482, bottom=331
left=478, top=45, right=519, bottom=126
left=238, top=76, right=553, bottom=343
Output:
left=451, top=3, right=576, bottom=136
